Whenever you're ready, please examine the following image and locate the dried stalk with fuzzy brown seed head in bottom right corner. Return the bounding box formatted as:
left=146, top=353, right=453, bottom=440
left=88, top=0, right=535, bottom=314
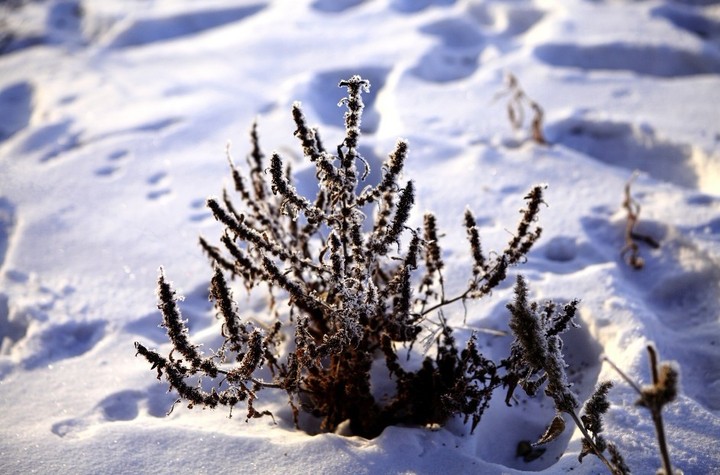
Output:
left=604, top=345, right=682, bottom=475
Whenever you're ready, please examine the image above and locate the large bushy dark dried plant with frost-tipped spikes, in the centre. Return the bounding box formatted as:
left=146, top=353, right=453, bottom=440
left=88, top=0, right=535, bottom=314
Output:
left=136, top=76, right=552, bottom=438
